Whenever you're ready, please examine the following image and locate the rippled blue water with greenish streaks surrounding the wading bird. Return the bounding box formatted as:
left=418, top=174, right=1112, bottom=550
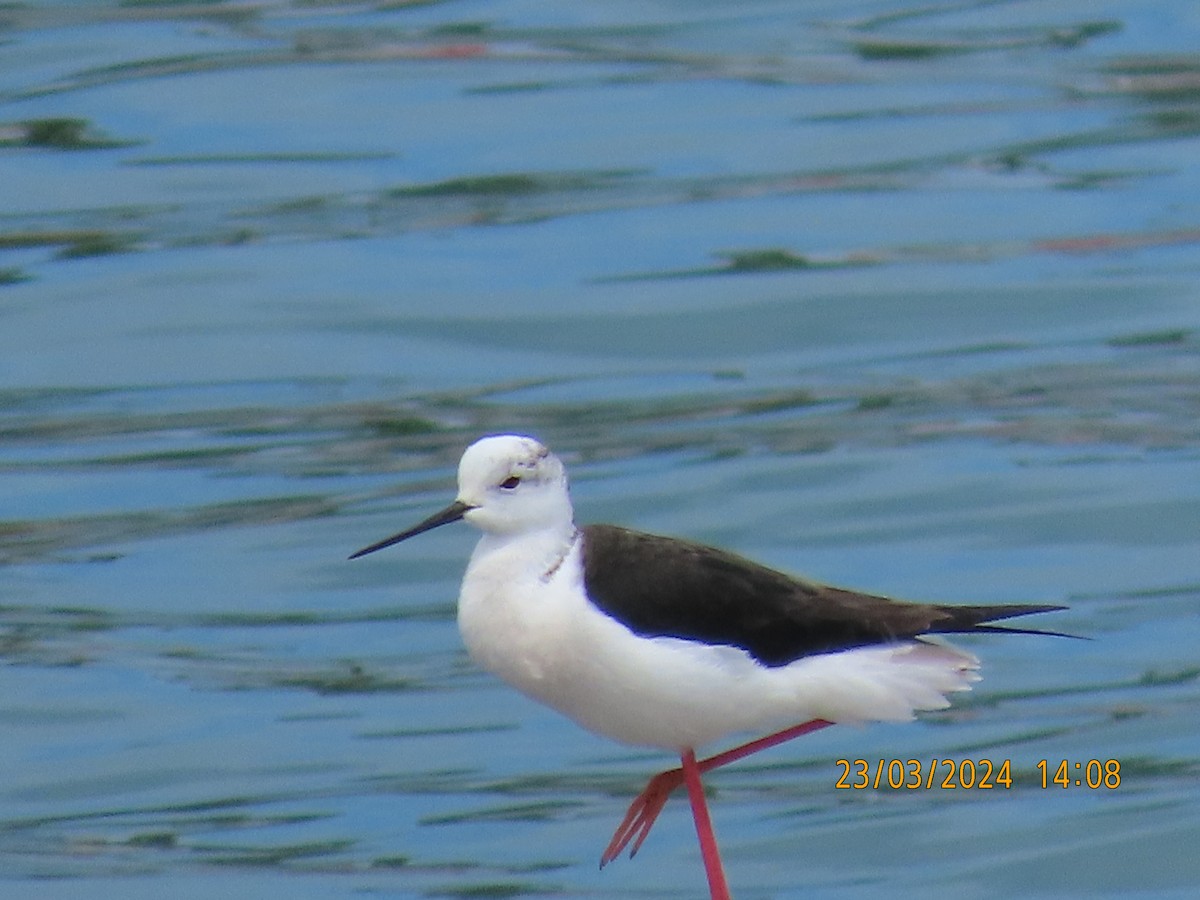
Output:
left=0, top=0, right=1200, bottom=900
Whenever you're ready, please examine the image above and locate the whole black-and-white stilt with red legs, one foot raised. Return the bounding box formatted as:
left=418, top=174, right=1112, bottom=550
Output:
left=350, top=434, right=1063, bottom=900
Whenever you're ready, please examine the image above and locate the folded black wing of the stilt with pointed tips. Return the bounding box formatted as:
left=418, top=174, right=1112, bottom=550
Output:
left=582, top=524, right=1063, bottom=666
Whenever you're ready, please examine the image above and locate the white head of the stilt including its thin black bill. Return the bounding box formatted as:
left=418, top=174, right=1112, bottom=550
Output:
left=350, top=434, right=575, bottom=559
